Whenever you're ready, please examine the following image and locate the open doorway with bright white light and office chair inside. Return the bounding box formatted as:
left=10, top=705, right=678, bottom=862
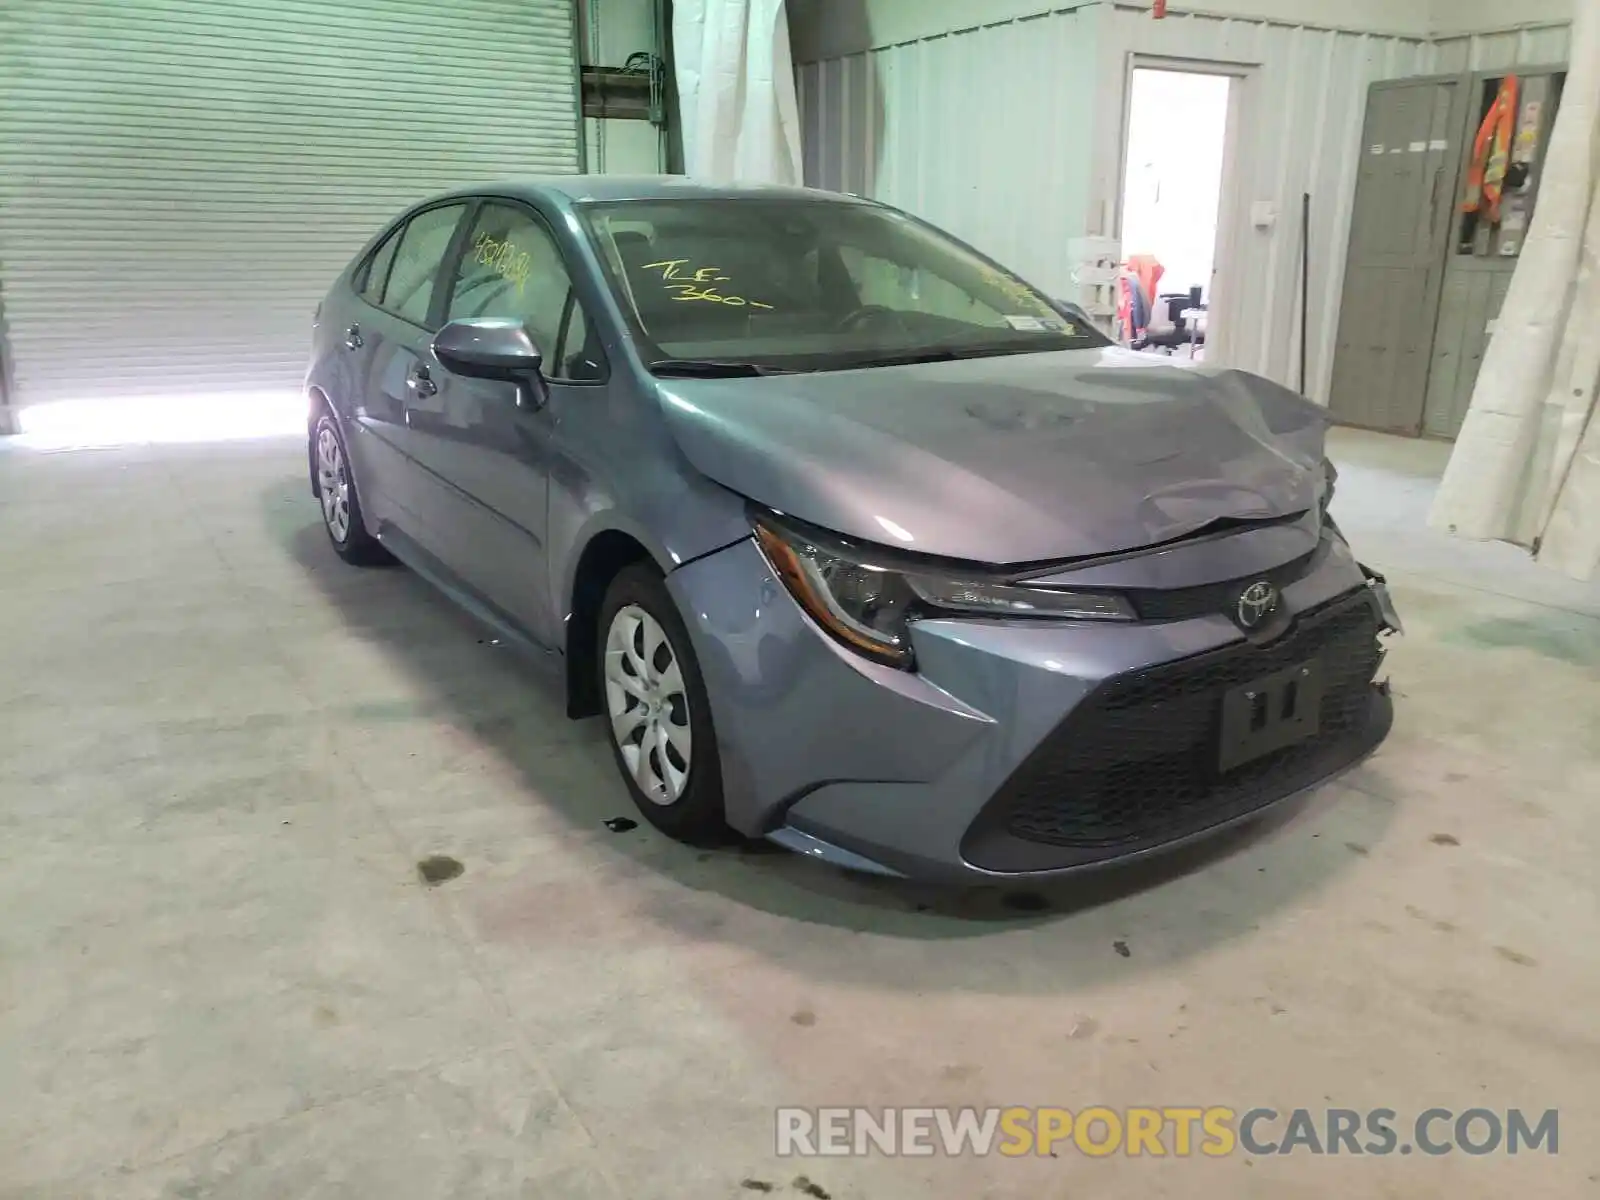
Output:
left=1118, top=66, right=1240, bottom=358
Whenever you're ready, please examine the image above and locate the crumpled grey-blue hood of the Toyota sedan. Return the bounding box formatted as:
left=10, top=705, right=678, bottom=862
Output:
left=659, top=347, right=1326, bottom=563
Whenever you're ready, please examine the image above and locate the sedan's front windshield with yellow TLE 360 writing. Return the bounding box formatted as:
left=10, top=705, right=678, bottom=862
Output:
left=584, top=197, right=1106, bottom=371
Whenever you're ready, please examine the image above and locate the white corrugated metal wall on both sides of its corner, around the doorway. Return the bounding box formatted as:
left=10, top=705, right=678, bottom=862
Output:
left=798, top=3, right=1432, bottom=400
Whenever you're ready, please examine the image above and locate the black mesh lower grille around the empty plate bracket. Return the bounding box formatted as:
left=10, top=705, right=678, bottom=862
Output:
left=968, top=590, right=1381, bottom=870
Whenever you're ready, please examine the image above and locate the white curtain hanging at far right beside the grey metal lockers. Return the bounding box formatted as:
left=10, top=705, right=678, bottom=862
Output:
left=1430, top=2, right=1600, bottom=579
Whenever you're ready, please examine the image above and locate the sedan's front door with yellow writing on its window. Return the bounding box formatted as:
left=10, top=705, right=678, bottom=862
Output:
left=406, top=200, right=606, bottom=645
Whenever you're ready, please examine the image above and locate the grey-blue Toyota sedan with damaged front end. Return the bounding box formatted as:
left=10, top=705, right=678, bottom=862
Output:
left=306, top=176, right=1398, bottom=882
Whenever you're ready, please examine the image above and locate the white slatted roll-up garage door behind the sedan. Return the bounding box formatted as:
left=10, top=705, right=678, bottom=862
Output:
left=0, top=0, right=579, bottom=405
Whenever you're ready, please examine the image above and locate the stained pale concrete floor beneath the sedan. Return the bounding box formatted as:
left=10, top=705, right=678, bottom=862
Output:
left=0, top=435, right=1600, bottom=1200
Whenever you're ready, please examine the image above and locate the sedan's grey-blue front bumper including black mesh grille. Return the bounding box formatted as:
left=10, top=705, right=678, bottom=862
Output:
left=669, top=534, right=1394, bottom=883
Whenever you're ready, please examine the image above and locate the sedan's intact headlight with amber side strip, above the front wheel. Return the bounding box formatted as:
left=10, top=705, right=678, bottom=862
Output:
left=755, top=518, right=1134, bottom=669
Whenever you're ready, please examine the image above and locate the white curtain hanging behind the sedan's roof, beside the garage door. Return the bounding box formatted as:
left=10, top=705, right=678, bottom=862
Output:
left=672, top=0, right=800, bottom=184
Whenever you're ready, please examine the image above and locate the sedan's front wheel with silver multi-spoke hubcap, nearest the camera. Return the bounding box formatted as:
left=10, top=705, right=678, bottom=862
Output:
left=595, top=563, right=730, bottom=846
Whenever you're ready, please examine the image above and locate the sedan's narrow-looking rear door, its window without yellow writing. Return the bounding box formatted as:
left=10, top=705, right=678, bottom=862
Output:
left=346, top=200, right=470, bottom=565
